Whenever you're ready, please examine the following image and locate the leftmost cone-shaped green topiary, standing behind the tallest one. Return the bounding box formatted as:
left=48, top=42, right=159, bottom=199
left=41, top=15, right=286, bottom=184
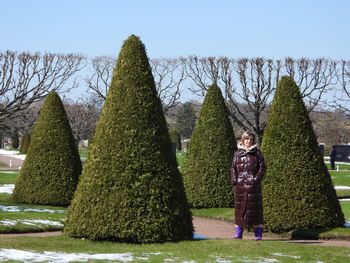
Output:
left=13, top=91, right=82, bottom=206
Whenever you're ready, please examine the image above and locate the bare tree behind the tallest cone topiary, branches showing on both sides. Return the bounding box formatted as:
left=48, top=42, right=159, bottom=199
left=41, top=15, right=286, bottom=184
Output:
left=84, top=56, right=185, bottom=112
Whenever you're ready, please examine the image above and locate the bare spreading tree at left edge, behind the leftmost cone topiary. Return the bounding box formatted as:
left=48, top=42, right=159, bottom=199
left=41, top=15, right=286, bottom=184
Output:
left=0, top=50, right=84, bottom=127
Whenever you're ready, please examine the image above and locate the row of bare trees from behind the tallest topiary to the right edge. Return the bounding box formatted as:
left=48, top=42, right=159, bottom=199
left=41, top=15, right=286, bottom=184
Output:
left=85, top=56, right=350, bottom=145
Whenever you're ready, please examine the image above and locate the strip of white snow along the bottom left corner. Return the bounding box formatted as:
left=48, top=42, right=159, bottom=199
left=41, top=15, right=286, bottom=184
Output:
left=0, top=251, right=160, bottom=263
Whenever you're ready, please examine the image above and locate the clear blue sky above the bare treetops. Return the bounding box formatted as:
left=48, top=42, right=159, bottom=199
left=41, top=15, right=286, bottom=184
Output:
left=0, top=0, right=350, bottom=59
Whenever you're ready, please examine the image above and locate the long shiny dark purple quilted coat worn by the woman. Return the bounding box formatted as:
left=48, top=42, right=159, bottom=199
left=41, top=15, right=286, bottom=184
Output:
left=231, top=145, right=265, bottom=226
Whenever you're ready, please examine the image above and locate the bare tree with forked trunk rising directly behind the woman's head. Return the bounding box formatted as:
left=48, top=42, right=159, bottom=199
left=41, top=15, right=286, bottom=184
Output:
left=182, top=56, right=281, bottom=144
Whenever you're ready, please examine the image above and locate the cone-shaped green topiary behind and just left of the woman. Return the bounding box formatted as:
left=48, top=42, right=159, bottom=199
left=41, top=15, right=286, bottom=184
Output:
left=183, top=84, right=237, bottom=208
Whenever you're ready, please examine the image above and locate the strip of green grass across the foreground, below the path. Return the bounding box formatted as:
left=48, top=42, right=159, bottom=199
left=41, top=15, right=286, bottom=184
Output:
left=0, top=236, right=349, bottom=262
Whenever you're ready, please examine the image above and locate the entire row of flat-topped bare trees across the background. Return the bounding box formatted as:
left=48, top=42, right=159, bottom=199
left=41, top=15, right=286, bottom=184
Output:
left=0, top=51, right=350, bottom=146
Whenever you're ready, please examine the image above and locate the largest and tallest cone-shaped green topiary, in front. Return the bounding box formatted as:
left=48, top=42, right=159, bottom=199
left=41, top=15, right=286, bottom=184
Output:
left=64, top=35, right=193, bottom=243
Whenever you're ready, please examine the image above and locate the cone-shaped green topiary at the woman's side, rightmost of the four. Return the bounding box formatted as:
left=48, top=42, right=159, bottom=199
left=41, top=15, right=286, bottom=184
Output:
left=261, top=77, right=344, bottom=232
